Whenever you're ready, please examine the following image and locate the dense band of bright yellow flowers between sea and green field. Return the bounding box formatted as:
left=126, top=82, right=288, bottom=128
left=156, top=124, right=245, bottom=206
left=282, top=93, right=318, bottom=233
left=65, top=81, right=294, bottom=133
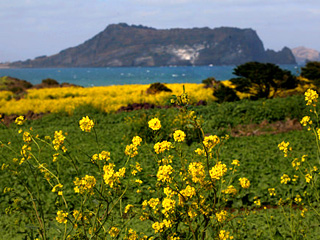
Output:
left=0, top=83, right=214, bottom=114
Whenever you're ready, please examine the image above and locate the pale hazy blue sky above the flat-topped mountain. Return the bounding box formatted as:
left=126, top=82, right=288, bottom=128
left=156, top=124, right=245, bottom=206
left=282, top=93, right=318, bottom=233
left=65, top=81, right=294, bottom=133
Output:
left=0, top=0, right=320, bottom=62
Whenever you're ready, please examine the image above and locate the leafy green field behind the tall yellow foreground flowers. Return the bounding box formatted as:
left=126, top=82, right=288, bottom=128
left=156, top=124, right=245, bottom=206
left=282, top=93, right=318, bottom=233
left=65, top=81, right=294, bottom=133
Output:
left=0, top=96, right=320, bottom=239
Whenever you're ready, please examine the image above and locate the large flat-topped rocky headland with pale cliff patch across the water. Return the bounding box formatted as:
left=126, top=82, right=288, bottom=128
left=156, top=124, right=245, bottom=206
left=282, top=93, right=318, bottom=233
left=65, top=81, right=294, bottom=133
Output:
left=10, top=23, right=295, bottom=67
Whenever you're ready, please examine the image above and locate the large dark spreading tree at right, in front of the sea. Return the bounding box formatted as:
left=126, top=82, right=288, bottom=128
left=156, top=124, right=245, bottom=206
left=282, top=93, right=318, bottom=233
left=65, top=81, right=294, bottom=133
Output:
left=230, top=62, right=298, bottom=99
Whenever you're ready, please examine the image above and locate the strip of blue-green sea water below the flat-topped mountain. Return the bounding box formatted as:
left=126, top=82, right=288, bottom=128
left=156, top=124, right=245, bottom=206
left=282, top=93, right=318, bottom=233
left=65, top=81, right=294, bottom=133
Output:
left=0, top=65, right=300, bottom=87
